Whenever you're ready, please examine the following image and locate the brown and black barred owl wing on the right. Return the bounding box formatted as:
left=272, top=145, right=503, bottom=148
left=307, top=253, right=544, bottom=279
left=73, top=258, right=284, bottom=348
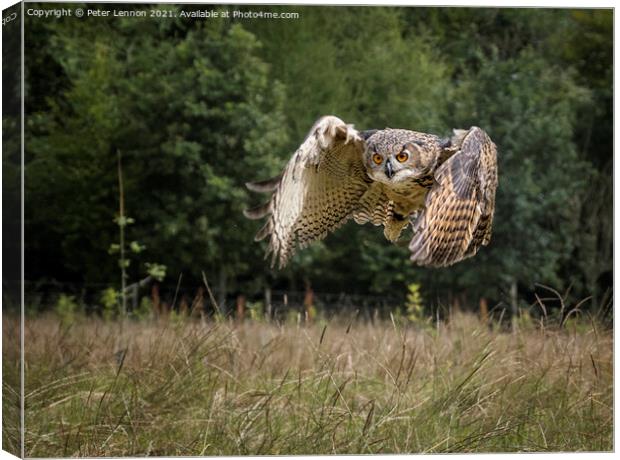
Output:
left=409, top=127, right=497, bottom=267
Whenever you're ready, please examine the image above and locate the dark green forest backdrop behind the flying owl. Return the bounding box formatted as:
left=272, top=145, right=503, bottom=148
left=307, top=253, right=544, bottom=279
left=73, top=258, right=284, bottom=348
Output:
left=3, top=4, right=613, bottom=320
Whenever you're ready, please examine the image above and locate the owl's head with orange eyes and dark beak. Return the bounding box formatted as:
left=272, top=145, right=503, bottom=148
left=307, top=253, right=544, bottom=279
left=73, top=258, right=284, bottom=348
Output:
left=364, top=128, right=440, bottom=185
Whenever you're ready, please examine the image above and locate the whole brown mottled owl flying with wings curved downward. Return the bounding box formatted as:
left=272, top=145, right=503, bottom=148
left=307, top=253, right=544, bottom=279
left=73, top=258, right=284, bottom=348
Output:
left=245, top=116, right=497, bottom=268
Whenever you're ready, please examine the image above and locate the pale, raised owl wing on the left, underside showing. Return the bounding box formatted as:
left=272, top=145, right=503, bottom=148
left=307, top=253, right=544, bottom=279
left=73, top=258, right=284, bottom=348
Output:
left=245, top=116, right=371, bottom=268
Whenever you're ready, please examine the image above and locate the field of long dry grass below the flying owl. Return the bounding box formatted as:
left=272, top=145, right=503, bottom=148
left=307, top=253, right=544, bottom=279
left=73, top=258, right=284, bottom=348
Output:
left=4, top=314, right=613, bottom=457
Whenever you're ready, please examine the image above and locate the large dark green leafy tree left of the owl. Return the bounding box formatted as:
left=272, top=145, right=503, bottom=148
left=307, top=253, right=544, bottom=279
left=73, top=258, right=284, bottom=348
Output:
left=27, top=8, right=286, bottom=306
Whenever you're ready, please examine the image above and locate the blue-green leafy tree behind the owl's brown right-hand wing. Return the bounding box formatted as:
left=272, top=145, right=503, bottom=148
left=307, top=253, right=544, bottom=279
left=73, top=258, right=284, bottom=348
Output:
left=402, top=9, right=609, bottom=310
